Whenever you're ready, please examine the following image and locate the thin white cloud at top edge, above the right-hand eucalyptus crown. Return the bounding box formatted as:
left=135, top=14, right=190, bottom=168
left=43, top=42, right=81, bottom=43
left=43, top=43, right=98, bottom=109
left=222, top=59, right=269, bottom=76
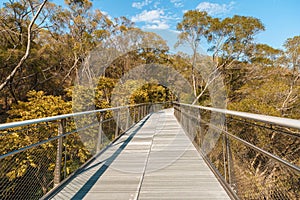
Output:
left=196, top=1, right=235, bottom=15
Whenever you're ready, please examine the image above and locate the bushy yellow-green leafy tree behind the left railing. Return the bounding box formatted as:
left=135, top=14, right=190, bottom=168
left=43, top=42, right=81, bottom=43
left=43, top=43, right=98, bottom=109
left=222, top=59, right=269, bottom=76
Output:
left=0, top=91, right=90, bottom=199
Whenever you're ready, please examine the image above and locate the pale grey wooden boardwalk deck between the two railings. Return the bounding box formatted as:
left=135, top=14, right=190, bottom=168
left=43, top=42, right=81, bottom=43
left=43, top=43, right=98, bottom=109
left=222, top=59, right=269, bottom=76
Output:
left=48, top=109, right=230, bottom=200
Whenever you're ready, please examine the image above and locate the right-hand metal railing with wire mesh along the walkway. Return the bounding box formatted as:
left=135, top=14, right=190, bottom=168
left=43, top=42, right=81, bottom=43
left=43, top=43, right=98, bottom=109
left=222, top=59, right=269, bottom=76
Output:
left=174, top=103, right=300, bottom=200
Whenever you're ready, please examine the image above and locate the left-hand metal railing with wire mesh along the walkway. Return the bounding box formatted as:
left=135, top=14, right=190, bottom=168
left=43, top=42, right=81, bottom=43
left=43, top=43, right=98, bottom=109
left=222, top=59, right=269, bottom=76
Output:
left=0, top=103, right=169, bottom=199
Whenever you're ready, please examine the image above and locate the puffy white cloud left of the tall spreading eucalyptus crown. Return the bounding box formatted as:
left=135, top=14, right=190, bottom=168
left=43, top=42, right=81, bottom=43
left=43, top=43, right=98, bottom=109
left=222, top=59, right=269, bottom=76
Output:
left=131, top=9, right=170, bottom=29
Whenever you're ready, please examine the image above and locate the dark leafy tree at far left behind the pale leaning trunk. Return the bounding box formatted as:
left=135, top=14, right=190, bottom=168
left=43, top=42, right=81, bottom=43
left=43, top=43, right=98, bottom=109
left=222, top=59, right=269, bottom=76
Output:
left=0, top=0, right=68, bottom=106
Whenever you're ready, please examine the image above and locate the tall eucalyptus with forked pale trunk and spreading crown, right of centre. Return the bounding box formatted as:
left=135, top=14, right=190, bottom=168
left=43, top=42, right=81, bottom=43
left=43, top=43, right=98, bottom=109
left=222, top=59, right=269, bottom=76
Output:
left=177, top=10, right=264, bottom=103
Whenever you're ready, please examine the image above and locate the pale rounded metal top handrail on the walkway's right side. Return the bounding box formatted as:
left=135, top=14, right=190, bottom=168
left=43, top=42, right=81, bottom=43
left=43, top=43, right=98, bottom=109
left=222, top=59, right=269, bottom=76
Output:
left=174, top=103, right=300, bottom=129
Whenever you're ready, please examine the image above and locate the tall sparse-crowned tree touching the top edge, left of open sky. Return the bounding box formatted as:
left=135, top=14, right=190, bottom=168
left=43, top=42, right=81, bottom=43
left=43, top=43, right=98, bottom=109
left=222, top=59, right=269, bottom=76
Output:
left=50, top=0, right=113, bottom=84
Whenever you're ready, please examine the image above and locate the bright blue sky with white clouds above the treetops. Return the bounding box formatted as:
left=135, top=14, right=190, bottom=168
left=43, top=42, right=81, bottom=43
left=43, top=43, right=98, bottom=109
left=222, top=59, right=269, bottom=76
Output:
left=0, top=0, right=300, bottom=50
